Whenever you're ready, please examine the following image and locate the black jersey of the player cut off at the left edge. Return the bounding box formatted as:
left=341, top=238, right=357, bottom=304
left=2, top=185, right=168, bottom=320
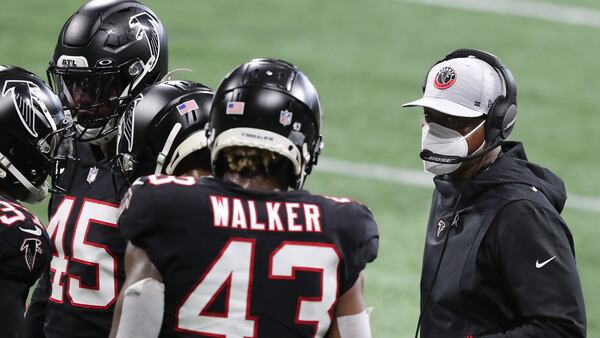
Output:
left=0, top=195, right=52, bottom=338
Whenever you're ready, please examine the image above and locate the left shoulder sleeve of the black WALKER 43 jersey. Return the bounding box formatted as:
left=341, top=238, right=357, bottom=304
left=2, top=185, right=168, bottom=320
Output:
left=118, top=179, right=156, bottom=249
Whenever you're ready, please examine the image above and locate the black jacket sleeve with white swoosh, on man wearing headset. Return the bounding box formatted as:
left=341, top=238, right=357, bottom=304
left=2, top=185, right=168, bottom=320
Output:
left=485, top=201, right=586, bottom=338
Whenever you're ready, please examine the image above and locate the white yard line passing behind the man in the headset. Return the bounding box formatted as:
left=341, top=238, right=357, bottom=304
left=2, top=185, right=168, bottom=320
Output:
left=322, top=158, right=600, bottom=212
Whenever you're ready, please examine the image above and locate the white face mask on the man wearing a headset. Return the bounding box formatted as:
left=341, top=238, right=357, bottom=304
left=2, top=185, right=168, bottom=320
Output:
left=421, top=121, right=485, bottom=175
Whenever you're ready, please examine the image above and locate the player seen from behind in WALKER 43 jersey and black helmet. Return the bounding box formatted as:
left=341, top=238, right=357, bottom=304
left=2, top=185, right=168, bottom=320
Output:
left=111, top=59, right=379, bottom=338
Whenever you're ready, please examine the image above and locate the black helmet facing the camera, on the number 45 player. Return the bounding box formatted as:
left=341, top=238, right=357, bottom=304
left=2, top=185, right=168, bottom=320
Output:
left=48, top=0, right=168, bottom=143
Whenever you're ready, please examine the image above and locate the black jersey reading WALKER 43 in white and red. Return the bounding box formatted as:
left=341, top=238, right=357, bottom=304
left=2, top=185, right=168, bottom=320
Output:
left=119, top=176, right=379, bottom=338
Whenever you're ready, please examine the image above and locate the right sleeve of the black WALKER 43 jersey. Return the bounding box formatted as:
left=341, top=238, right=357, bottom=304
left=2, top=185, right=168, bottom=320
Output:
left=340, top=202, right=379, bottom=294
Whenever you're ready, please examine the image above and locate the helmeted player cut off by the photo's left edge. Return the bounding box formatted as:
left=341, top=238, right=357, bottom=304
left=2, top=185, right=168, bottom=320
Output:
left=0, top=66, right=68, bottom=338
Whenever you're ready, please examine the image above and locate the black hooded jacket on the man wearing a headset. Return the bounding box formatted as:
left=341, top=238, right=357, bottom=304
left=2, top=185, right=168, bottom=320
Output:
left=421, top=142, right=586, bottom=338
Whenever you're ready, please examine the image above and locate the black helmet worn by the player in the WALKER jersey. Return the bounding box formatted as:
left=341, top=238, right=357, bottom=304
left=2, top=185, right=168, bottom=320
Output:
left=209, top=59, right=323, bottom=189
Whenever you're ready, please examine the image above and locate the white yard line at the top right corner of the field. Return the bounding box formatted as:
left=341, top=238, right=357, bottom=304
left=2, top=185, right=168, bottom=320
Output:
left=391, top=0, right=600, bottom=27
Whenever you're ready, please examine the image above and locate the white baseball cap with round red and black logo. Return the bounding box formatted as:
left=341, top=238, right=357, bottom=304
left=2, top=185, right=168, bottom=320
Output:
left=402, top=56, right=506, bottom=117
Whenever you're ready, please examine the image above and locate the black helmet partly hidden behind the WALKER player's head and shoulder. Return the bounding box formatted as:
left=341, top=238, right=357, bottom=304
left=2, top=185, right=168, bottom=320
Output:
left=112, top=80, right=214, bottom=182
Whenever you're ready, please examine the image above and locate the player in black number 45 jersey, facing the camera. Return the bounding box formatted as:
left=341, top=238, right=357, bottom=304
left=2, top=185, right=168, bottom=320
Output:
left=27, top=0, right=167, bottom=338
